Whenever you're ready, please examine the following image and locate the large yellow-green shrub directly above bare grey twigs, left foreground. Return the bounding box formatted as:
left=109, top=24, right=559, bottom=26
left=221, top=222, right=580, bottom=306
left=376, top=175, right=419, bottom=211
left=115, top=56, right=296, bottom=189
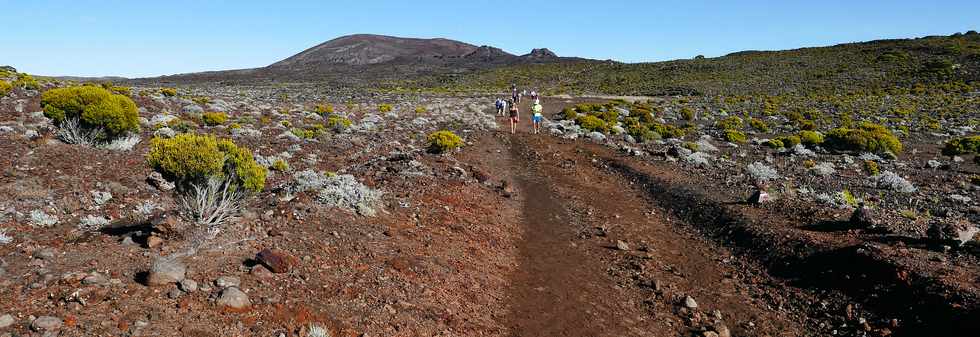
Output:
left=146, top=133, right=267, bottom=192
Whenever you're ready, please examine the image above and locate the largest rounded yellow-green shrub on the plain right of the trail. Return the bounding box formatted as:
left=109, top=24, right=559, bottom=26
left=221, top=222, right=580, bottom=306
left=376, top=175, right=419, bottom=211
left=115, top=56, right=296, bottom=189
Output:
left=826, top=122, right=902, bottom=154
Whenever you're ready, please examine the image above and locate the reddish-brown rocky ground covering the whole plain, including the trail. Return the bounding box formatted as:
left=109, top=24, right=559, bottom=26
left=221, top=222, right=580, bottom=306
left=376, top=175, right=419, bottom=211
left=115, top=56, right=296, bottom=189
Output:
left=0, top=80, right=980, bottom=336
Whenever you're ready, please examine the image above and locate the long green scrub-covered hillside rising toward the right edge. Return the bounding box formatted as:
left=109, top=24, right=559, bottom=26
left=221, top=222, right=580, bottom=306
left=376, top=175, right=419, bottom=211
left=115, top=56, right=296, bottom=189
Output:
left=420, top=31, right=980, bottom=95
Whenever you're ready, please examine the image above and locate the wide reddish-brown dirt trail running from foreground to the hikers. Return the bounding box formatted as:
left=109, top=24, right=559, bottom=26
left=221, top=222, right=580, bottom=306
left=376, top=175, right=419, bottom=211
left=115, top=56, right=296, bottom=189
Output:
left=486, top=96, right=806, bottom=336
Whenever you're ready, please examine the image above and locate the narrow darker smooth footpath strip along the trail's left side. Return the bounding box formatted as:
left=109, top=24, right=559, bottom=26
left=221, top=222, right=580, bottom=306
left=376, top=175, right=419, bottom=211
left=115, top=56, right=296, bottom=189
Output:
left=502, top=133, right=622, bottom=336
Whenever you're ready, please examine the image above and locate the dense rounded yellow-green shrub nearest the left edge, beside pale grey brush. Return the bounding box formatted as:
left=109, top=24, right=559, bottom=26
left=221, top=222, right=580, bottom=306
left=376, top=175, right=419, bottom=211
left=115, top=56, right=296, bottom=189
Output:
left=41, top=86, right=139, bottom=138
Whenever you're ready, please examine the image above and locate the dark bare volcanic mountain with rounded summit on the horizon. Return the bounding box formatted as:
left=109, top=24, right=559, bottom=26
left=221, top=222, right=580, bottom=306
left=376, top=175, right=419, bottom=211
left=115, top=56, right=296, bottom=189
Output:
left=138, top=34, right=581, bottom=83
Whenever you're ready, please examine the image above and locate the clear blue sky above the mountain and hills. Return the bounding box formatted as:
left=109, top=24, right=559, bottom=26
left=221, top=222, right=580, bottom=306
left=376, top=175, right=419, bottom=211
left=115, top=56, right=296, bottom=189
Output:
left=0, top=0, right=980, bottom=77
